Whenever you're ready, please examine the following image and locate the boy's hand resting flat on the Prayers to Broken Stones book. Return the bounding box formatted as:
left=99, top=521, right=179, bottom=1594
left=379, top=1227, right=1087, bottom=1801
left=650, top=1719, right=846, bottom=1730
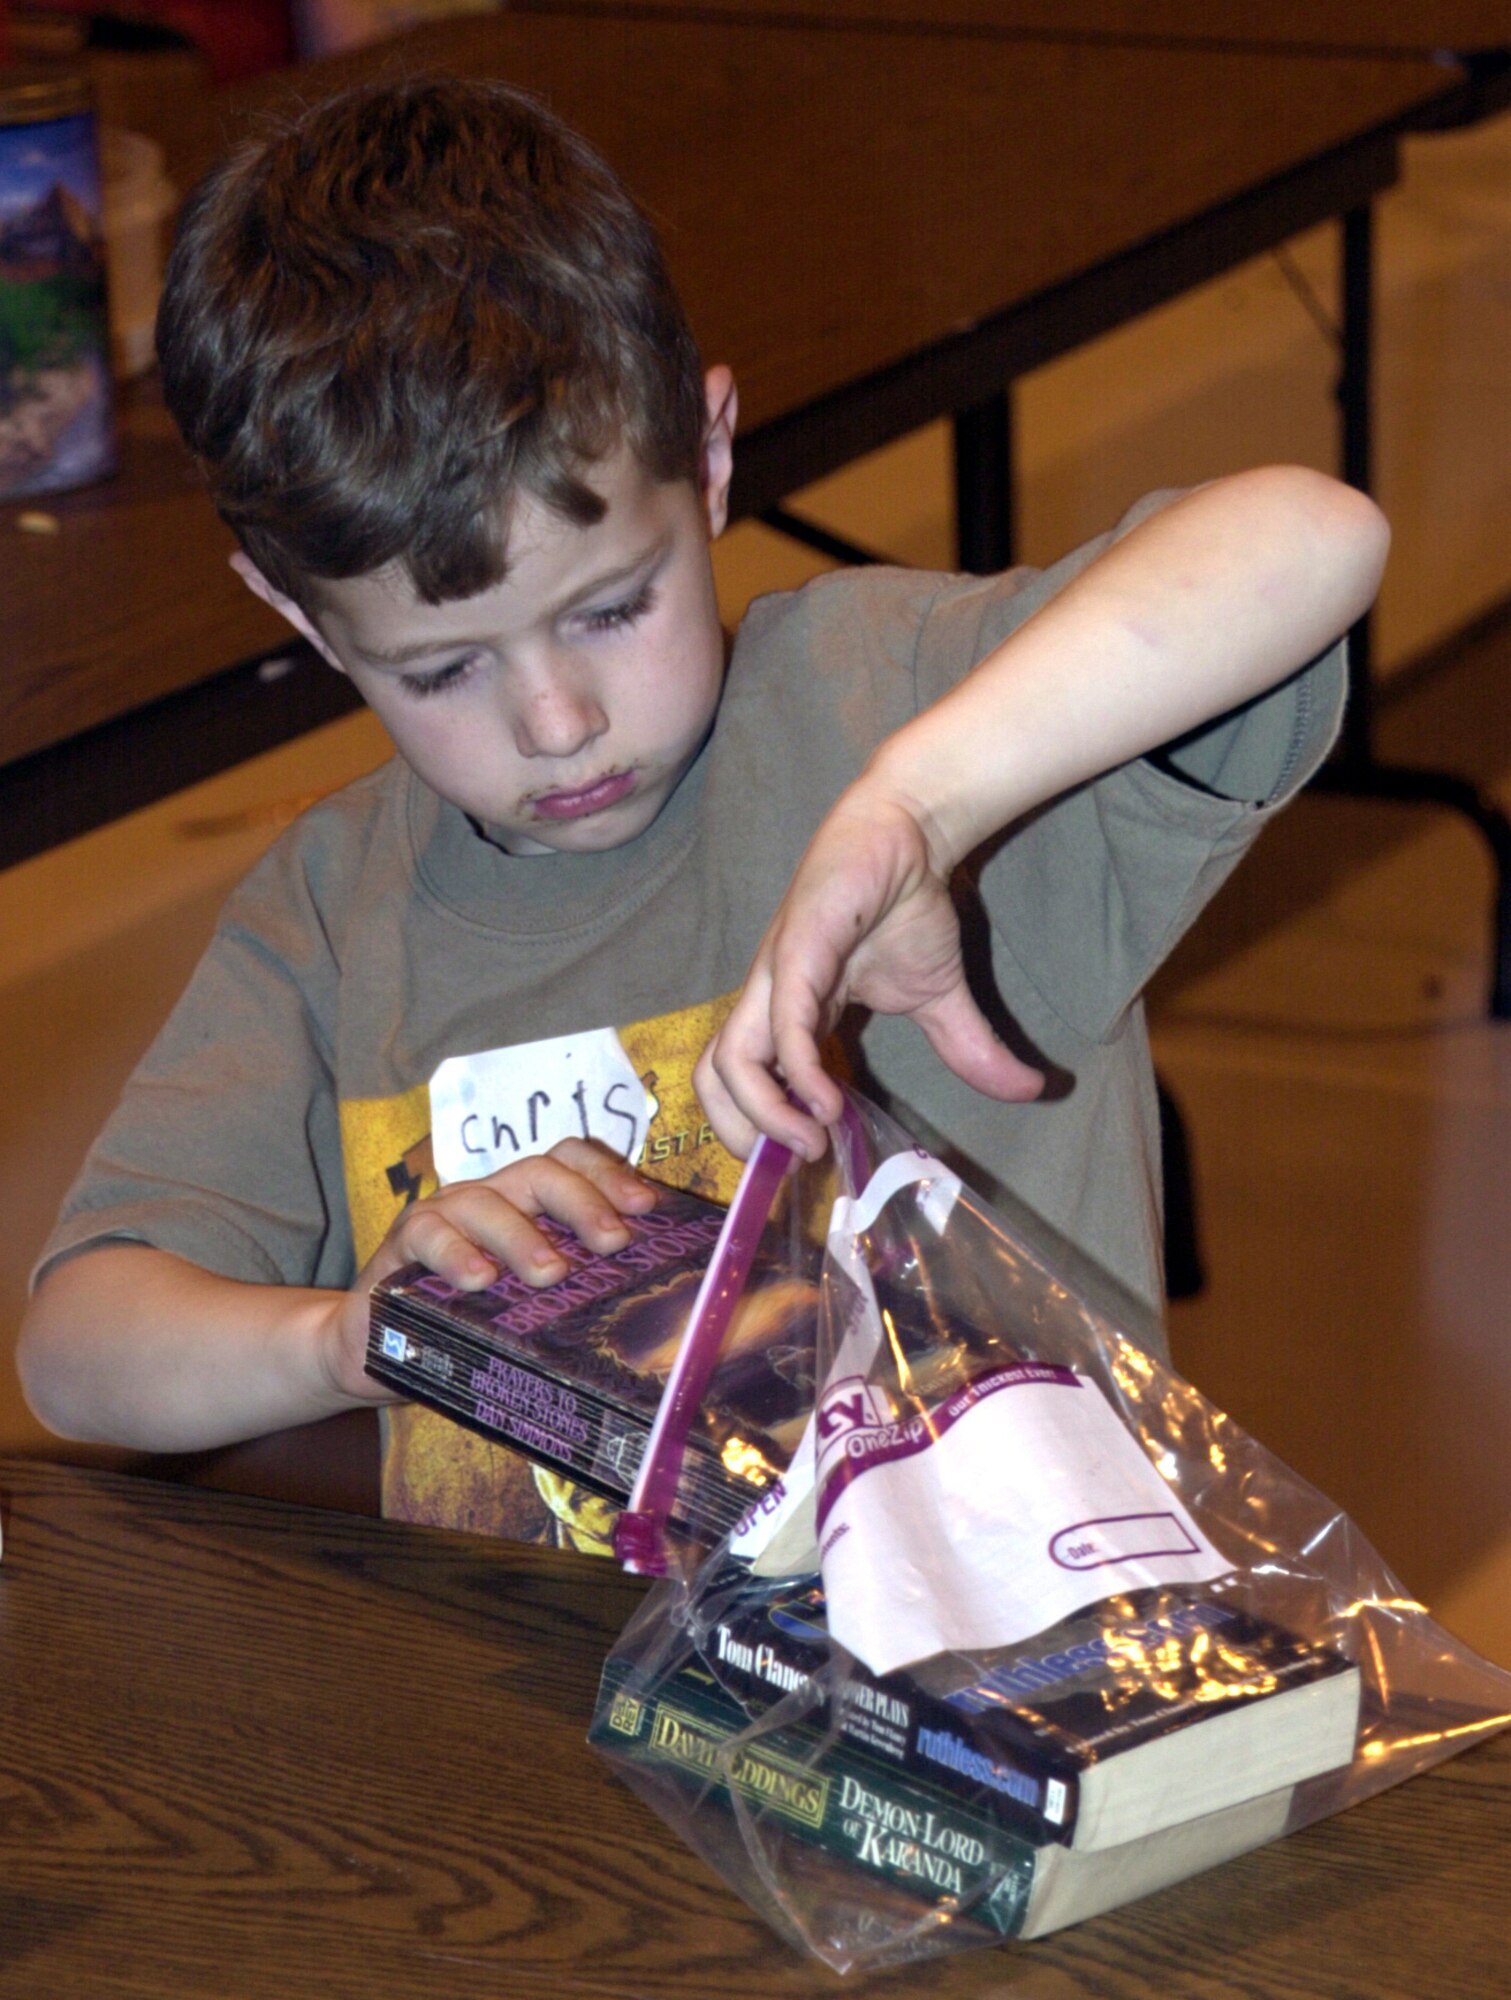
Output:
left=330, top=1138, right=656, bottom=1402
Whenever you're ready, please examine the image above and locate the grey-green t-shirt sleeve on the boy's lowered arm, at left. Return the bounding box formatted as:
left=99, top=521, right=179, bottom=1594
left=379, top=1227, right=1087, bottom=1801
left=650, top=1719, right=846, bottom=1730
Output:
left=38, top=820, right=352, bottom=1284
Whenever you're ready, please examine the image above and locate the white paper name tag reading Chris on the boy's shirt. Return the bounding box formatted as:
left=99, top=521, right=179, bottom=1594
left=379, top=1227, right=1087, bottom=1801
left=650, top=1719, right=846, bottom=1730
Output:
left=430, top=1028, right=658, bottom=1186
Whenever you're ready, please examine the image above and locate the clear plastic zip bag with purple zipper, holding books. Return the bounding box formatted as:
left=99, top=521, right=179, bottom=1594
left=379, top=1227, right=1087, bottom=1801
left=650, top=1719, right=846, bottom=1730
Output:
left=592, top=1094, right=1511, bottom=1972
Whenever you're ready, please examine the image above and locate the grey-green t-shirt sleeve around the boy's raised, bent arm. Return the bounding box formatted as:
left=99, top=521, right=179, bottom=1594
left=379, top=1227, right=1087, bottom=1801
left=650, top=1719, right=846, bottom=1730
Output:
left=917, top=496, right=1347, bottom=1058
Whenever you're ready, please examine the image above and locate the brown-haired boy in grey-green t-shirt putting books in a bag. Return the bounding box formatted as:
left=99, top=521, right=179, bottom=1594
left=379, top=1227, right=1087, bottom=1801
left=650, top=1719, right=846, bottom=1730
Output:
left=20, top=80, right=1385, bottom=1546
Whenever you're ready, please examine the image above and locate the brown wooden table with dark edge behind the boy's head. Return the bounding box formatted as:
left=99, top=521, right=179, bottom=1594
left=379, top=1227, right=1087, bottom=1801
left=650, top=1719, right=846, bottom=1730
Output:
left=0, top=10, right=1457, bottom=864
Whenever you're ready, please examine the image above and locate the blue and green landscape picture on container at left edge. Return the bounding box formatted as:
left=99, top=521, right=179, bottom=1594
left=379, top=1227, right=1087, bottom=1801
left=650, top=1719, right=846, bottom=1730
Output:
left=0, top=114, right=114, bottom=500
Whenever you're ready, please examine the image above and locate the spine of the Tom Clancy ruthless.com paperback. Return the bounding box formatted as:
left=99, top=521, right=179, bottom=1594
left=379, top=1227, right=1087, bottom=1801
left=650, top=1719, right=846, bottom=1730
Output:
left=702, top=1606, right=1079, bottom=1846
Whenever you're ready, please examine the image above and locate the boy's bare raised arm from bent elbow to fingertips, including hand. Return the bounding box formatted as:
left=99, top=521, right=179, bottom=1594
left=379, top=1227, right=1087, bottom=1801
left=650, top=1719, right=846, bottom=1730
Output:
left=696, top=466, right=1387, bottom=1158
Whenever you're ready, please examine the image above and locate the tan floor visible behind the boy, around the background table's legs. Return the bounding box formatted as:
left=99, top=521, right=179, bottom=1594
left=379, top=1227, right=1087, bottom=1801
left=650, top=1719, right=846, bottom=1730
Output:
left=0, top=118, right=1511, bottom=1662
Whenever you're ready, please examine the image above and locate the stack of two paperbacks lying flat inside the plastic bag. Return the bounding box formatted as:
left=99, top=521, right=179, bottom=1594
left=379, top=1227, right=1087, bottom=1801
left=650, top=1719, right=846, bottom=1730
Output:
left=592, top=1578, right=1359, bottom=1938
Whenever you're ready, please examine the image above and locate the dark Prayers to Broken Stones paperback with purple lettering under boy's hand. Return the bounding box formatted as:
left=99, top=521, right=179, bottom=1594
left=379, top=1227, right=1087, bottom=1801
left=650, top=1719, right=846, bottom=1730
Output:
left=366, top=1188, right=817, bottom=1542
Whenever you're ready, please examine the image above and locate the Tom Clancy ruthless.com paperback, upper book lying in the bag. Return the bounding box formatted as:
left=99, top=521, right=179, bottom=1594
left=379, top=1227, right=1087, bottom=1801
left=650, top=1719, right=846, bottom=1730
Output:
left=702, top=1578, right=1359, bottom=1852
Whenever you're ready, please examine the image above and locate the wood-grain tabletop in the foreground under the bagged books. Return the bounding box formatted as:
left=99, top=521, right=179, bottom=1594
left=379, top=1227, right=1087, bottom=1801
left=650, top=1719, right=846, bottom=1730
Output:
left=0, top=1460, right=1511, bottom=2000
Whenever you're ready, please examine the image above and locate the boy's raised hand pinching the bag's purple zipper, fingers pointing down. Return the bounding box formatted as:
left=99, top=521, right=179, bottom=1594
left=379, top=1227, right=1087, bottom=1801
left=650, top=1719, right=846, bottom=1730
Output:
left=694, top=780, right=1043, bottom=1160
